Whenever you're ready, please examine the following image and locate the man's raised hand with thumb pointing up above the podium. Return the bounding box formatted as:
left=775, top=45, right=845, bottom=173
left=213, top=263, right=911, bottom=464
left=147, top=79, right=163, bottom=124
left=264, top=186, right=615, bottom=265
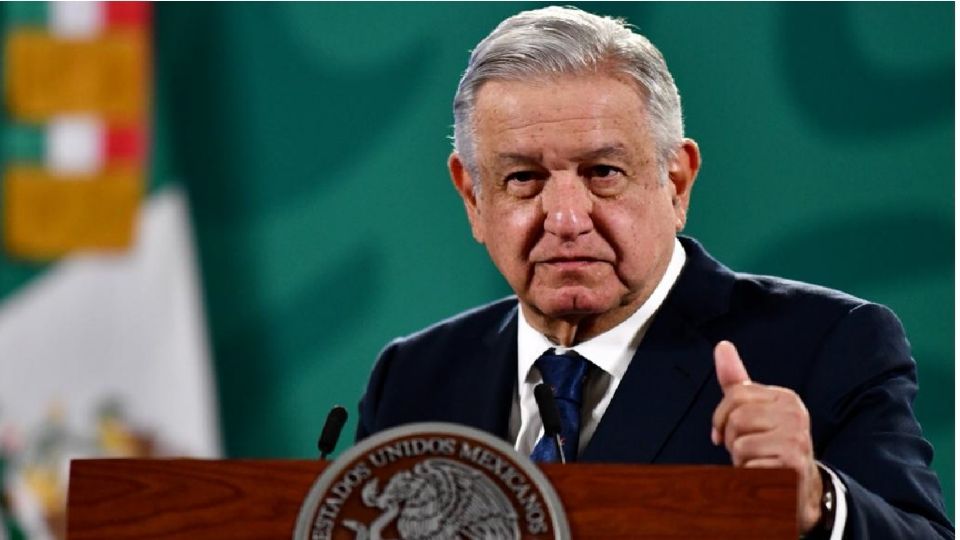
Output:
left=710, top=341, right=823, bottom=534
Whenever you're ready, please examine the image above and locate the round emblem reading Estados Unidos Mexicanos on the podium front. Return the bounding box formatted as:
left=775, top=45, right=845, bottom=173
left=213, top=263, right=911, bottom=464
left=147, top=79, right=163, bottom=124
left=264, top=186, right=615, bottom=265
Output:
left=293, top=423, right=570, bottom=540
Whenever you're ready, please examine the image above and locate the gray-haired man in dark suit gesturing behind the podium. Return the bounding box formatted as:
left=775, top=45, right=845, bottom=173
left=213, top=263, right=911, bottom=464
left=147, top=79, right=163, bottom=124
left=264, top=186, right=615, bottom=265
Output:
left=358, top=8, right=953, bottom=538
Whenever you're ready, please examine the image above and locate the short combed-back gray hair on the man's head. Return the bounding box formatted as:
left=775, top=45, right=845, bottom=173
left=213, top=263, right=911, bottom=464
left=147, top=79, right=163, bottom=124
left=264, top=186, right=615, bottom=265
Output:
left=453, top=6, right=683, bottom=184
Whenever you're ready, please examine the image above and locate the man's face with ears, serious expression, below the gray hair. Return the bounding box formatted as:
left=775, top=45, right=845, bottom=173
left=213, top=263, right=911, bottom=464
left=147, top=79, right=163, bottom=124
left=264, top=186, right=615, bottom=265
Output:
left=450, top=75, right=699, bottom=343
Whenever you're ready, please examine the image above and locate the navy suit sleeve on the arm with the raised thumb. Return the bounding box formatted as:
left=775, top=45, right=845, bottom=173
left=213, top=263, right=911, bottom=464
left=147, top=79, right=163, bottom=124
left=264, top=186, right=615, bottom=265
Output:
left=810, top=304, right=954, bottom=539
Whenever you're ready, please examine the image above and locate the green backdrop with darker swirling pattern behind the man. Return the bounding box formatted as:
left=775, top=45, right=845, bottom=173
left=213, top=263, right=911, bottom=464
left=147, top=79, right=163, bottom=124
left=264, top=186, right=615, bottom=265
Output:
left=0, top=3, right=955, bottom=515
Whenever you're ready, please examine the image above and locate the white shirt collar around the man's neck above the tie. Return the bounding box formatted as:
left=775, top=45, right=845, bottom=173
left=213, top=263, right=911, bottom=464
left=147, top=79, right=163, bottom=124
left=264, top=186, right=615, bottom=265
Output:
left=517, top=239, right=687, bottom=384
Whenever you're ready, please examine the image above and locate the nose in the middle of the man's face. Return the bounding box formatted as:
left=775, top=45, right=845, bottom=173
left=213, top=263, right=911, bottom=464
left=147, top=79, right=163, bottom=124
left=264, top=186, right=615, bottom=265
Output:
left=541, top=175, right=593, bottom=240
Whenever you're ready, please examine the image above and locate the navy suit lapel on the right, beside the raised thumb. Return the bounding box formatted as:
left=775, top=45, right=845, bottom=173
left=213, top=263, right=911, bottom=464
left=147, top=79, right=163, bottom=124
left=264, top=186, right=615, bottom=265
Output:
left=580, top=238, right=734, bottom=463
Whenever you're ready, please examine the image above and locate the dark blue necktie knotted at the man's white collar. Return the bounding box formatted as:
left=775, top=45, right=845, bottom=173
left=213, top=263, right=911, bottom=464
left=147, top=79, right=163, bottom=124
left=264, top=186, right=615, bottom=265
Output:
left=530, top=349, right=590, bottom=463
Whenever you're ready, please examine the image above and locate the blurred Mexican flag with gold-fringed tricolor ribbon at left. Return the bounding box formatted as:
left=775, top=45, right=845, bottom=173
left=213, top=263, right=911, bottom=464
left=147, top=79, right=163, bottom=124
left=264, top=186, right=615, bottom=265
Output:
left=0, top=2, right=220, bottom=538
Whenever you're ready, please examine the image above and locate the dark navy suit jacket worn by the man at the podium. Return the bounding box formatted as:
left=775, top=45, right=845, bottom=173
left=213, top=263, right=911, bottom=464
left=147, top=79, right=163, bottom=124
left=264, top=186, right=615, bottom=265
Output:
left=357, top=238, right=954, bottom=539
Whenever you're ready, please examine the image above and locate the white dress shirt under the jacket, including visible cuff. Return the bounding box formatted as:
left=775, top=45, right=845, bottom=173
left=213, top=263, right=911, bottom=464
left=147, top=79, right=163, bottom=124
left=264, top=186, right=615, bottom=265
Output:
left=510, top=240, right=847, bottom=540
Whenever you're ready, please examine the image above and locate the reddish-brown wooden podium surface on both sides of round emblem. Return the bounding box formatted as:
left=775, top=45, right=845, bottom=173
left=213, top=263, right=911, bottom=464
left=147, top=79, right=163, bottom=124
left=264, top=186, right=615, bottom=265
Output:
left=67, top=459, right=797, bottom=540
